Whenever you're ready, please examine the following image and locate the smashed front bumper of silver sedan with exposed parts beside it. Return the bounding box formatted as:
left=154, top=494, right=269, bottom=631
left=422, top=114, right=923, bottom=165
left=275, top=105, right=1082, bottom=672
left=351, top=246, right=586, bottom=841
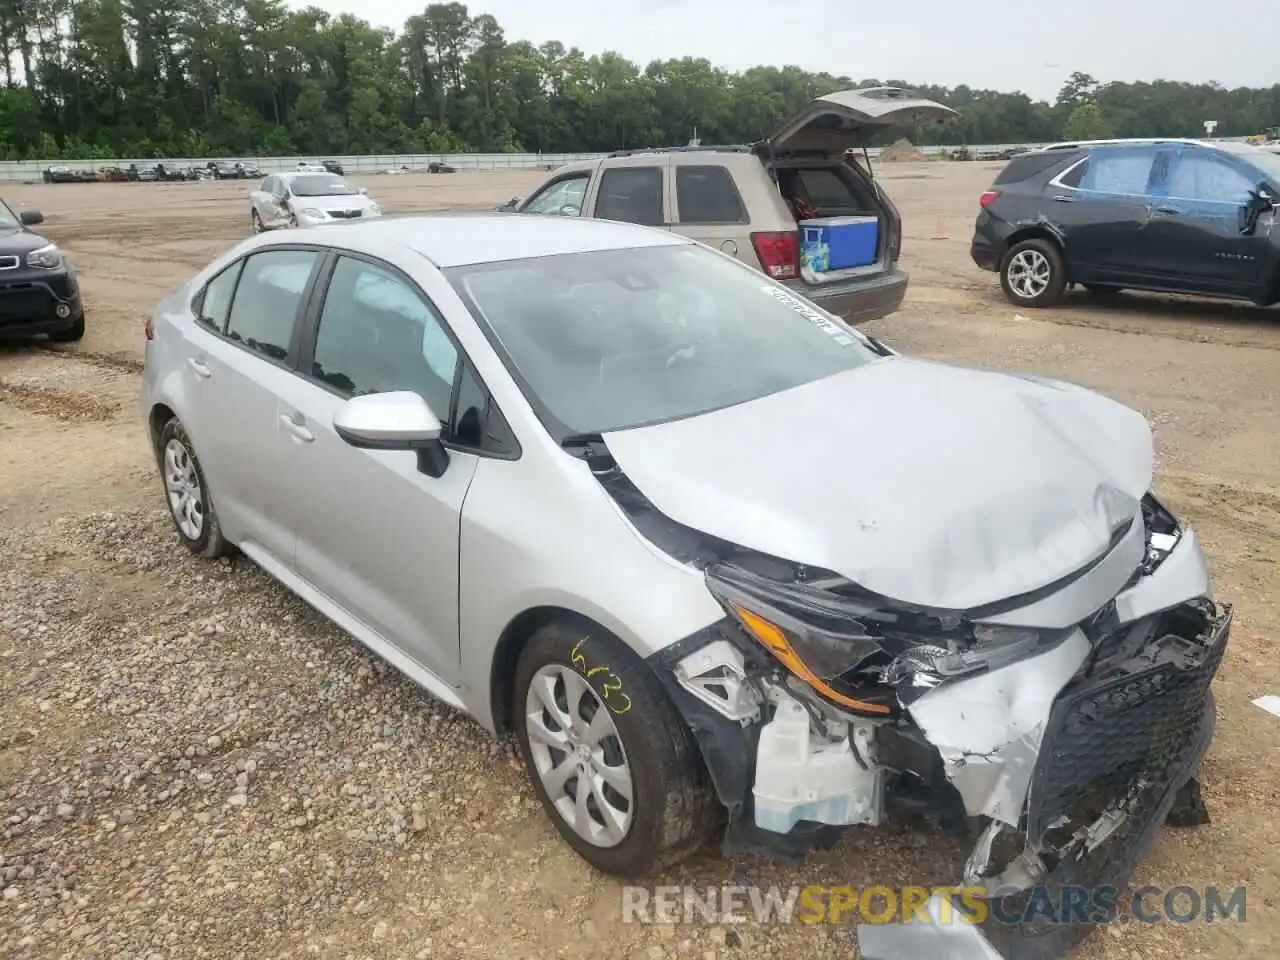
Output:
left=653, top=530, right=1233, bottom=960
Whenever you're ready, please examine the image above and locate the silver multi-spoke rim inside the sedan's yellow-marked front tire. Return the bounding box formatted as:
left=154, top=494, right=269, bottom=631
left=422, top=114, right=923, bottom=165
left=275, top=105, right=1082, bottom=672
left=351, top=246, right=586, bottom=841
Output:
left=525, top=663, right=635, bottom=847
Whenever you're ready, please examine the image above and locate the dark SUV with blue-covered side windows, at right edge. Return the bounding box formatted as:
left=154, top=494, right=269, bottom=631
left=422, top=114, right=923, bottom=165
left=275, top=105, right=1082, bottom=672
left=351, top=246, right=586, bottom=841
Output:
left=970, top=140, right=1280, bottom=307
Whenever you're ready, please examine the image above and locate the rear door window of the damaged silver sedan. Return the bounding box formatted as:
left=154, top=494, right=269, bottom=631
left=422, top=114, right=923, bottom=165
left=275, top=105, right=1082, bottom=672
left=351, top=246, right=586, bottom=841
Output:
left=227, top=250, right=319, bottom=360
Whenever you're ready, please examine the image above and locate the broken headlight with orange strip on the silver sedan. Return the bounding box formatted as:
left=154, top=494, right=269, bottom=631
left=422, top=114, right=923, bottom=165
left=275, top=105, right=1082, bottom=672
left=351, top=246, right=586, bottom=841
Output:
left=707, top=564, right=1070, bottom=716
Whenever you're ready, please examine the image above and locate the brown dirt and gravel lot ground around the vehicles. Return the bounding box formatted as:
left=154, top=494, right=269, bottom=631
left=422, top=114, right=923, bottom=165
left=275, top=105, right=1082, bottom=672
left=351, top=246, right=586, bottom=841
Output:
left=0, top=164, right=1280, bottom=960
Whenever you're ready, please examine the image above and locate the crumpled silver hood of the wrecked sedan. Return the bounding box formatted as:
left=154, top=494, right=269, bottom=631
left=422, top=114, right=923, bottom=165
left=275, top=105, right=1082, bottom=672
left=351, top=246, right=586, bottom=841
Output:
left=604, top=357, right=1152, bottom=609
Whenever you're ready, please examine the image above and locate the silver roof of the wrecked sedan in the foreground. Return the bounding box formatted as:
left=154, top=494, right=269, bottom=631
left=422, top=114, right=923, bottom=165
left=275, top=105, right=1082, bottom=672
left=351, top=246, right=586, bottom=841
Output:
left=252, top=214, right=692, bottom=268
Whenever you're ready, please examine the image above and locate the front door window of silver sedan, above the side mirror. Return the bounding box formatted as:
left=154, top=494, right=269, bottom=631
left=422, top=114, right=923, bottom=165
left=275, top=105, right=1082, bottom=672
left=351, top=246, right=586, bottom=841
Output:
left=311, top=257, right=458, bottom=421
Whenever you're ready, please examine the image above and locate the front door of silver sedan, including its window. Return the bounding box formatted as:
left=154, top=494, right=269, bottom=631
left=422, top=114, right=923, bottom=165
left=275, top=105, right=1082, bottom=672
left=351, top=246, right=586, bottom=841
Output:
left=272, top=256, right=476, bottom=682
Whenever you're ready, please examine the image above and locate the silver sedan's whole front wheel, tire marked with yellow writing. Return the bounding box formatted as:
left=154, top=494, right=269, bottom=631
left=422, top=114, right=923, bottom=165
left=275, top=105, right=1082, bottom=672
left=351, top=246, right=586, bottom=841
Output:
left=515, top=620, right=723, bottom=878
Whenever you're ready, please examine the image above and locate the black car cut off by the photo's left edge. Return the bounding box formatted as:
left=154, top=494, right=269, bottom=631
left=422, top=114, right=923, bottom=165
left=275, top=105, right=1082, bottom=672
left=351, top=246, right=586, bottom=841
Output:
left=0, top=200, right=84, bottom=343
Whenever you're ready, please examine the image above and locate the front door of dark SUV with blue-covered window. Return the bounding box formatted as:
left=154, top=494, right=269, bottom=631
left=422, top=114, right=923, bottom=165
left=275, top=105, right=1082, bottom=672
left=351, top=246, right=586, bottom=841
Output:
left=1147, top=145, right=1270, bottom=296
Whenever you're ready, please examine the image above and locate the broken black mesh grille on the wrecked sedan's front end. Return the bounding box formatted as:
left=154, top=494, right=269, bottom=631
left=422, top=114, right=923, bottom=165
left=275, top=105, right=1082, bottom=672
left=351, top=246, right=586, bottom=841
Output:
left=1028, top=605, right=1231, bottom=845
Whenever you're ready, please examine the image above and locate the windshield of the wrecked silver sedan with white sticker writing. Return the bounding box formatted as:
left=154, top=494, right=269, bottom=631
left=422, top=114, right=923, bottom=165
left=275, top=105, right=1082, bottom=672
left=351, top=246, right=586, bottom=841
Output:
left=445, top=243, right=879, bottom=440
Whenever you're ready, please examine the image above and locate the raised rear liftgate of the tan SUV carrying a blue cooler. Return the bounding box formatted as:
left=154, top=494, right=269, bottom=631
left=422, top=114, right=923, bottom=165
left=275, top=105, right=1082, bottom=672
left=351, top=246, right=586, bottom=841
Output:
left=756, top=87, right=959, bottom=154
